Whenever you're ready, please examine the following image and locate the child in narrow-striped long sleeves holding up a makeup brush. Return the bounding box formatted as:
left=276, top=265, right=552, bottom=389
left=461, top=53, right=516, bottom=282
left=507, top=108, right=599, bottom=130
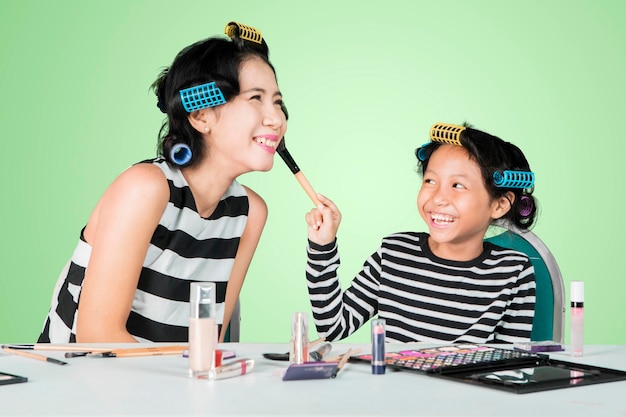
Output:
left=306, top=124, right=536, bottom=343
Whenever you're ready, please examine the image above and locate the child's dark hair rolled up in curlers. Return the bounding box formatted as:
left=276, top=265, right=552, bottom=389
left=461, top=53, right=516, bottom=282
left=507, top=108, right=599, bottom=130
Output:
left=415, top=124, right=537, bottom=229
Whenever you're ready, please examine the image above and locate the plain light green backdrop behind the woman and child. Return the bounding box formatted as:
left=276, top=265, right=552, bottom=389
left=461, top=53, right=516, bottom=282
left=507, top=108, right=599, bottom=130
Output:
left=0, top=0, right=626, bottom=344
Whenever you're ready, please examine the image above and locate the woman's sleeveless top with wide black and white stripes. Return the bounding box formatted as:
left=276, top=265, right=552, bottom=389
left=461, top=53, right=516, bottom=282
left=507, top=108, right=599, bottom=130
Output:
left=39, top=159, right=249, bottom=343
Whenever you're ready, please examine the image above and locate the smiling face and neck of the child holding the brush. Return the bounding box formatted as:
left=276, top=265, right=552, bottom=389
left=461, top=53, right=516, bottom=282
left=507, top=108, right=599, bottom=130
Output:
left=417, top=144, right=509, bottom=260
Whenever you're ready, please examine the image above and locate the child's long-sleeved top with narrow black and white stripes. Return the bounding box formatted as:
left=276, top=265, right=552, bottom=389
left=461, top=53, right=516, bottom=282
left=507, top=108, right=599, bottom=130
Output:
left=306, top=232, right=535, bottom=343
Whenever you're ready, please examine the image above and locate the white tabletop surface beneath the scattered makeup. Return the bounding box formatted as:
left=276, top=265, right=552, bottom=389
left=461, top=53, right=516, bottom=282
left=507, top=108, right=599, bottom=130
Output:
left=0, top=343, right=626, bottom=417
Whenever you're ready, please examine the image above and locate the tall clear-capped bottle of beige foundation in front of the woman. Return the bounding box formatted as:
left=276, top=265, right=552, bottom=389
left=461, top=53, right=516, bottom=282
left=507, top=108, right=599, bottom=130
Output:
left=189, top=282, right=218, bottom=379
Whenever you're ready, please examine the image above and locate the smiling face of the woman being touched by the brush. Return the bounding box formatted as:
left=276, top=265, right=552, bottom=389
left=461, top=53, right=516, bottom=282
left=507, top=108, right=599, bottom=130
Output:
left=202, top=57, right=287, bottom=173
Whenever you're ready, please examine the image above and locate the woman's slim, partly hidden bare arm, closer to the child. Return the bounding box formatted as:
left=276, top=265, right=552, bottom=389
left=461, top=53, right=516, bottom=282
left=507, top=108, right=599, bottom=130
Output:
left=219, top=187, right=267, bottom=342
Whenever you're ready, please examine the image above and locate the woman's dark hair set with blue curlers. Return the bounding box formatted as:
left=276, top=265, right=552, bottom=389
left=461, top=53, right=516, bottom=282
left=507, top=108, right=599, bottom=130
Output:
left=152, top=37, right=276, bottom=166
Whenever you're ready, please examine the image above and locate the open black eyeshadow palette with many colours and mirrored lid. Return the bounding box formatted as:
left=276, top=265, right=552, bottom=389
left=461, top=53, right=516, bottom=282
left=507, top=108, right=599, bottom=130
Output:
left=351, top=344, right=626, bottom=394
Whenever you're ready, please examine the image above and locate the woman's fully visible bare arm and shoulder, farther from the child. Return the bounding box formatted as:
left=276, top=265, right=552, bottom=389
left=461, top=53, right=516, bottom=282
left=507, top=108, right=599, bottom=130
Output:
left=76, top=164, right=169, bottom=343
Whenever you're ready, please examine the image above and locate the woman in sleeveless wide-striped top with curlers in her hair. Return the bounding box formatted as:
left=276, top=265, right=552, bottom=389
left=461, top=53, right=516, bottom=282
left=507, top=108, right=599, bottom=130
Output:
left=39, top=22, right=287, bottom=343
